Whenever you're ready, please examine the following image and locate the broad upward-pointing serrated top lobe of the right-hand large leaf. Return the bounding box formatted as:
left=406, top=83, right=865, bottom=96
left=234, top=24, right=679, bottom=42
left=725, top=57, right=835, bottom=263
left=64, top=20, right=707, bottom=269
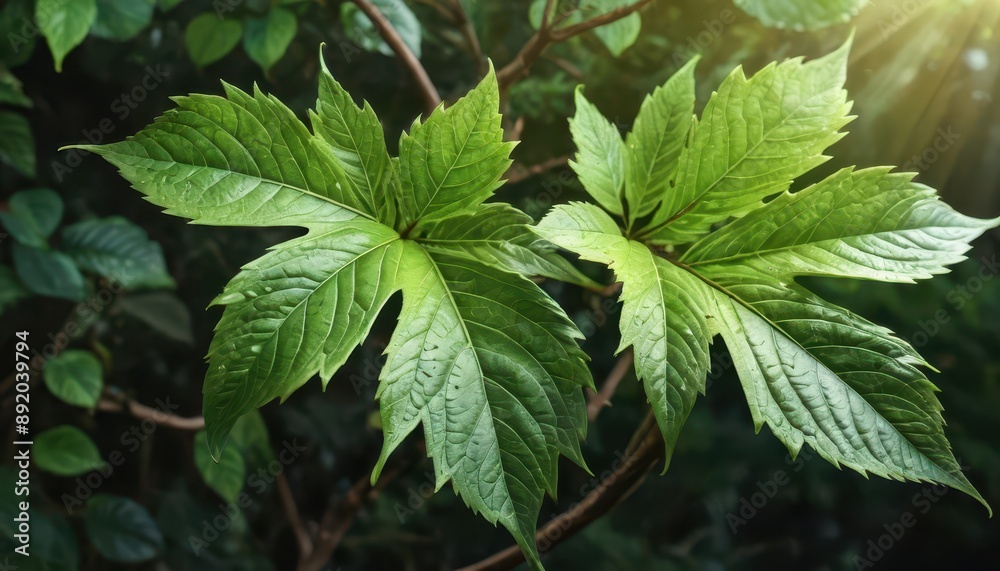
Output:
left=640, top=41, right=851, bottom=244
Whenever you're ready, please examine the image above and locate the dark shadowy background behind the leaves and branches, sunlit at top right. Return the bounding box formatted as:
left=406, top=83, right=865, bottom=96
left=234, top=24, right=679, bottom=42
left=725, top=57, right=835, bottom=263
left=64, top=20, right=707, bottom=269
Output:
left=0, top=0, right=1000, bottom=571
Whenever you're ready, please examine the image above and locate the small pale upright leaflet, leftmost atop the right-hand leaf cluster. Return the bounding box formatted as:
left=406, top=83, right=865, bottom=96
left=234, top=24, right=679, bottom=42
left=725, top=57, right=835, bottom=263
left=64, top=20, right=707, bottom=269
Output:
left=569, top=86, right=625, bottom=216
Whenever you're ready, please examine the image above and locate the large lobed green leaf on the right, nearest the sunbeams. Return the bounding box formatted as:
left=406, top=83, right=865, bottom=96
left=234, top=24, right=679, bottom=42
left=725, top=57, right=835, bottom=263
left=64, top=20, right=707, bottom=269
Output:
left=535, top=39, right=1000, bottom=508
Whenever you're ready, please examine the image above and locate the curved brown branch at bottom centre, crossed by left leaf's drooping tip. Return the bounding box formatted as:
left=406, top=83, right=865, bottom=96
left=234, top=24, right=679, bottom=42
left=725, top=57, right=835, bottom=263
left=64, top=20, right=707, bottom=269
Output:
left=458, top=423, right=664, bottom=571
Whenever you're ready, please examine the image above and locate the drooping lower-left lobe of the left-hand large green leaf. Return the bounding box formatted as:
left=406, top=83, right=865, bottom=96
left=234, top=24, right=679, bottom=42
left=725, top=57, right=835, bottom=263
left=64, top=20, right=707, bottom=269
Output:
left=204, top=220, right=402, bottom=458
